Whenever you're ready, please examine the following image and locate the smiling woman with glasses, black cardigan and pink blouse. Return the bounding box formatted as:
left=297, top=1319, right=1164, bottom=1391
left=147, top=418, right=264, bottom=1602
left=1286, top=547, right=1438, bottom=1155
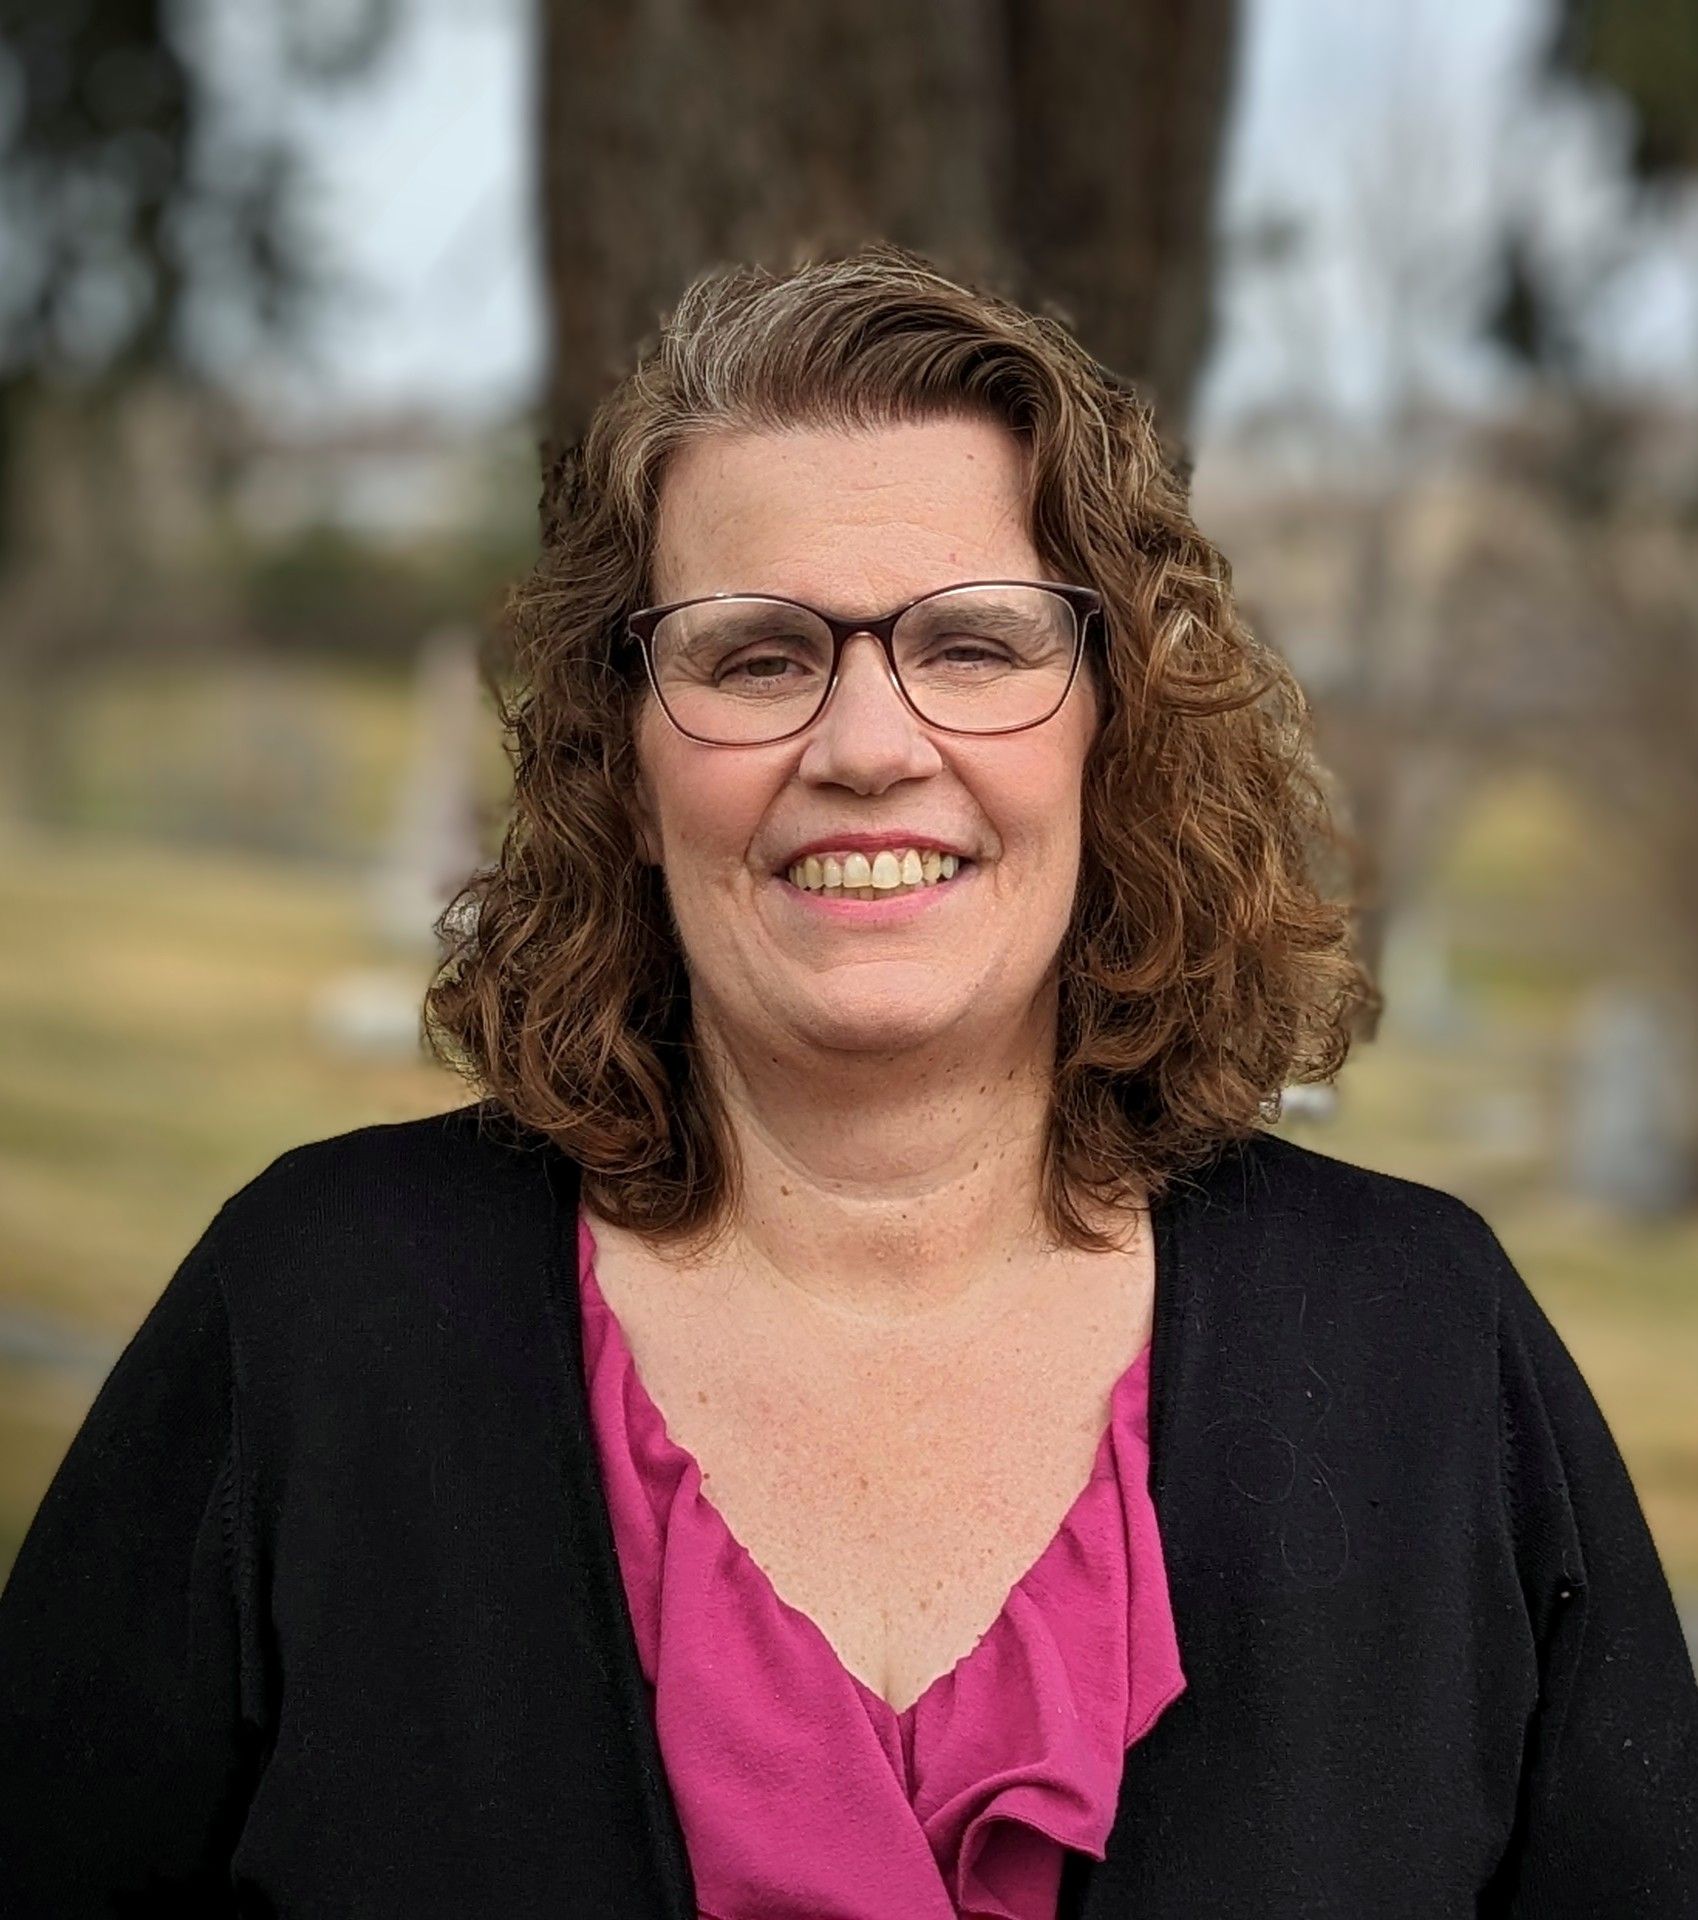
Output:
left=0, top=248, right=1698, bottom=1920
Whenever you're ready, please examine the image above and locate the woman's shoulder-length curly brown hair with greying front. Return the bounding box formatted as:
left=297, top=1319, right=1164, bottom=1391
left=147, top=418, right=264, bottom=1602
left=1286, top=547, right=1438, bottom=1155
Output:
left=425, top=242, right=1379, bottom=1248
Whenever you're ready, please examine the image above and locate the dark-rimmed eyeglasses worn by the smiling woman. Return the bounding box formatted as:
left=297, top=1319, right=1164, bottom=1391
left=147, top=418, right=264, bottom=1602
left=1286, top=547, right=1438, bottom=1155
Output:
left=628, top=580, right=1103, bottom=747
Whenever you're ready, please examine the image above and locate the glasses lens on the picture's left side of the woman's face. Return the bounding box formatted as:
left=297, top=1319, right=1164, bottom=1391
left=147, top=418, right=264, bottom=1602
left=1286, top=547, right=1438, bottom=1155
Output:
left=651, top=599, right=832, bottom=745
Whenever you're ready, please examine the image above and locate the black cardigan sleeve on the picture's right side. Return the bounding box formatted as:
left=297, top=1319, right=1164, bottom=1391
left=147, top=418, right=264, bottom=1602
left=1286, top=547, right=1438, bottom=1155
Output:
left=1492, top=1238, right=1698, bottom=1920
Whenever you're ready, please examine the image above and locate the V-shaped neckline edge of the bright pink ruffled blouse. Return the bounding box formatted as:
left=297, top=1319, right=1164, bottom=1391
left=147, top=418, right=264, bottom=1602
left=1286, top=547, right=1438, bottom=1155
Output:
left=578, top=1210, right=1160, bottom=1732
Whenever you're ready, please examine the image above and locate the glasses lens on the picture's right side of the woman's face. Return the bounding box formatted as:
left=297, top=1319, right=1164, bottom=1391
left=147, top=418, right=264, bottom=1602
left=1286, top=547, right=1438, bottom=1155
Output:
left=895, top=586, right=1078, bottom=733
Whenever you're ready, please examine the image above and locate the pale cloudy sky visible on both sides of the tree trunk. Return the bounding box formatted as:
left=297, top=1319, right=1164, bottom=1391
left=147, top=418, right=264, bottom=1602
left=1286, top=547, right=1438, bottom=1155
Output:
left=245, top=0, right=1698, bottom=424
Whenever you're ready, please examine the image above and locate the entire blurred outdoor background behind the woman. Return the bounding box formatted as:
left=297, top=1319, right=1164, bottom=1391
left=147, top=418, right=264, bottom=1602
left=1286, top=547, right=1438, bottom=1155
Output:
left=0, top=0, right=1698, bottom=1651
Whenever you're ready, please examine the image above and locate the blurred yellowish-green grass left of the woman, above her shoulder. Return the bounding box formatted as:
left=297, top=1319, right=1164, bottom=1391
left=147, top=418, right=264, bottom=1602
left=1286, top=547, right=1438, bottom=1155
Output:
left=0, top=835, right=465, bottom=1351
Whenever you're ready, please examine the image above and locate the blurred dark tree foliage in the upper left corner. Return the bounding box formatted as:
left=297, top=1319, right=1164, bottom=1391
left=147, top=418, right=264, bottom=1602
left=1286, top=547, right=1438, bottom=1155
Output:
left=0, top=0, right=401, bottom=810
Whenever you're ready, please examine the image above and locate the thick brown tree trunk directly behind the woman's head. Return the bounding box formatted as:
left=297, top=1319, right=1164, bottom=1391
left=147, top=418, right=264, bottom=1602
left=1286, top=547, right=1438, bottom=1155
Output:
left=540, top=0, right=1239, bottom=460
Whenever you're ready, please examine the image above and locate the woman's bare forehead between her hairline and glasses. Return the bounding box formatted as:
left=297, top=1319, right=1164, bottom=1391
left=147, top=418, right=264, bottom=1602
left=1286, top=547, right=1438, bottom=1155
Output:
left=655, top=419, right=1043, bottom=609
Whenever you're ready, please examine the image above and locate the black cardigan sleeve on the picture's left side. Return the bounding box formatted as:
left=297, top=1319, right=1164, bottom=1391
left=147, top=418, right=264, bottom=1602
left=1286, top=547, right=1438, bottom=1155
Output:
left=0, top=1223, right=254, bottom=1920
